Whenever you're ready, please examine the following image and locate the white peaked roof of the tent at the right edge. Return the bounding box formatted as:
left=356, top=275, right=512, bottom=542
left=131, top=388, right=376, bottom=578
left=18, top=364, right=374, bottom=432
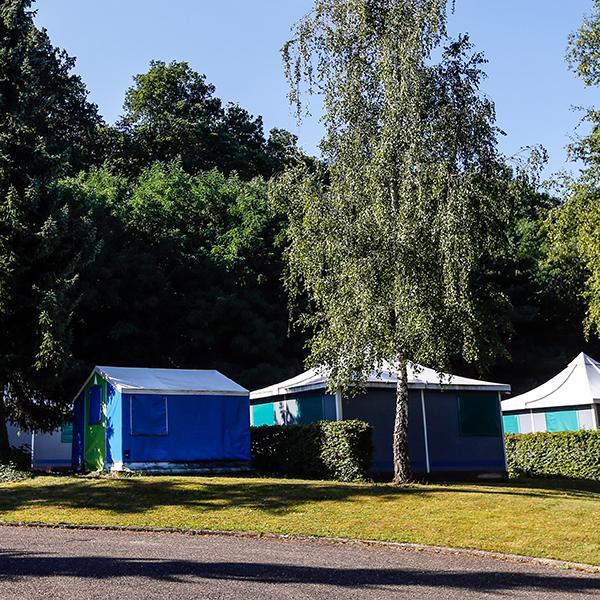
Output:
left=502, top=352, right=600, bottom=412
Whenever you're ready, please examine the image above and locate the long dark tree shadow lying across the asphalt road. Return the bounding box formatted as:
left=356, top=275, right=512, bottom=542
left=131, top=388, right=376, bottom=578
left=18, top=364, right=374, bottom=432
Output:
left=0, top=548, right=600, bottom=595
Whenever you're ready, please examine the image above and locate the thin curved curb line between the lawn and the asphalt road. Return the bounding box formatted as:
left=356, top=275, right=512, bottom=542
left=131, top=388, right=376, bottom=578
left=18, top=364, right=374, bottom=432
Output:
left=0, top=520, right=600, bottom=574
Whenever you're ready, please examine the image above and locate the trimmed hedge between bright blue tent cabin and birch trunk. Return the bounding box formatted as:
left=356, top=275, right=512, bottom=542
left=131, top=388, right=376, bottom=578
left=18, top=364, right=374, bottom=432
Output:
left=251, top=420, right=373, bottom=481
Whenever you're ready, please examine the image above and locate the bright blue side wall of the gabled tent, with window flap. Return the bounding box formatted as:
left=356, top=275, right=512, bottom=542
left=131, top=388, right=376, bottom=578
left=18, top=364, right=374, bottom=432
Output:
left=121, top=393, right=250, bottom=464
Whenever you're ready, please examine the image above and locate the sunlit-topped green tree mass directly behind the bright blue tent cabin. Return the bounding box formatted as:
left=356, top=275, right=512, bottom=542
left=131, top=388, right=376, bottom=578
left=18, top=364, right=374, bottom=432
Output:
left=65, top=161, right=299, bottom=386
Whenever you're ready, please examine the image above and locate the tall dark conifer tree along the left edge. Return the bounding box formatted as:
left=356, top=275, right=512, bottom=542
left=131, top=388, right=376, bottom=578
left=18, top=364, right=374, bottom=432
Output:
left=0, top=0, right=103, bottom=453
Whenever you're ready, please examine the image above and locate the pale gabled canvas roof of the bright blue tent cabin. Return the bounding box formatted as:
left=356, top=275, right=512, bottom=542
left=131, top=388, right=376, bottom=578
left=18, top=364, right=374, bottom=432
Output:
left=84, top=367, right=248, bottom=396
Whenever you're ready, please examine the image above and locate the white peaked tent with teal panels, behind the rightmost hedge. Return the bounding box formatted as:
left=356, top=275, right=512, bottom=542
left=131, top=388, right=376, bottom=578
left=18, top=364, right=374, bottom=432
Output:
left=502, top=352, right=600, bottom=433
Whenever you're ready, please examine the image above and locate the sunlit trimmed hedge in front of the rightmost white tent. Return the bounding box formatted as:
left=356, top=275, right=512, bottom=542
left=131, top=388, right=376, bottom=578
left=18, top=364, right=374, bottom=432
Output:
left=506, top=431, right=600, bottom=481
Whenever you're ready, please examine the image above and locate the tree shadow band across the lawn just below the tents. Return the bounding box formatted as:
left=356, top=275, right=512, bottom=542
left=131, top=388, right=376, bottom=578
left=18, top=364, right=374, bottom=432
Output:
left=0, top=476, right=600, bottom=516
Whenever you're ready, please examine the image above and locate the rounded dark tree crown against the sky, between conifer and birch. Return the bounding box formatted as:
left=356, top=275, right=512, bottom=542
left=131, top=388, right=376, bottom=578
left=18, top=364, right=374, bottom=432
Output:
left=118, top=61, right=297, bottom=179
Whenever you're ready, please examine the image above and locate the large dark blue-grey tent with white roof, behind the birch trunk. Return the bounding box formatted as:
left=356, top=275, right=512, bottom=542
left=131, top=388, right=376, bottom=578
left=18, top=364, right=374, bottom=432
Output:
left=250, top=365, right=510, bottom=478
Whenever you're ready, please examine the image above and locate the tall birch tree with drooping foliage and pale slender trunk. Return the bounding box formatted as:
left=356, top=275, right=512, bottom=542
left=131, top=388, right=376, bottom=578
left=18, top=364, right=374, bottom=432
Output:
left=274, top=0, right=513, bottom=483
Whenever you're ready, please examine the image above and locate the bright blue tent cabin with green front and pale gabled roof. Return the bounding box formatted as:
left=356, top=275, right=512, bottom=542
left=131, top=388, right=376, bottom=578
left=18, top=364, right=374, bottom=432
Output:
left=72, top=367, right=250, bottom=472
